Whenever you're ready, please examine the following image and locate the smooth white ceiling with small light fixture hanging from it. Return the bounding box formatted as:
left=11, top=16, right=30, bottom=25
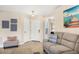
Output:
left=0, top=5, right=58, bottom=16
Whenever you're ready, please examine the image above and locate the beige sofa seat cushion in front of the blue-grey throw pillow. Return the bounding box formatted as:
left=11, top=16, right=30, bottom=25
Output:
left=49, top=44, right=72, bottom=54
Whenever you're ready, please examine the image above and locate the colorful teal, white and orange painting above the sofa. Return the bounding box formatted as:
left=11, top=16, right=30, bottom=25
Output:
left=64, top=5, right=79, bottom=28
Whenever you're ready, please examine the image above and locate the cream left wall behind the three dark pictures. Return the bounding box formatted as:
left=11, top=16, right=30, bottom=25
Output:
left=0, top=12, right=26, bottom=47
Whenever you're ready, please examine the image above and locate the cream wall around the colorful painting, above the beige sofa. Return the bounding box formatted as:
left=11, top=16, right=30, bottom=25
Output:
left=53, top=5, right=79, bottom=34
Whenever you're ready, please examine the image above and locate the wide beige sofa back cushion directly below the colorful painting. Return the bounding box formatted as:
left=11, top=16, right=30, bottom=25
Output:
left=61, top=33, right=78, bottom=49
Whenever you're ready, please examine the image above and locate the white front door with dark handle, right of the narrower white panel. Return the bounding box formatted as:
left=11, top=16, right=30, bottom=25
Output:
left=31, top=17, right=42, bottom=41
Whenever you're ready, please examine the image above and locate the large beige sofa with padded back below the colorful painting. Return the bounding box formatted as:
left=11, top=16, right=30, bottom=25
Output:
left=44, top=32, right=79, bottom=54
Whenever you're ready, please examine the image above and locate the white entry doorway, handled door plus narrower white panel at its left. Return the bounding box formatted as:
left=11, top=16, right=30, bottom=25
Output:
left=24, top=17, right=43, bottom=42
